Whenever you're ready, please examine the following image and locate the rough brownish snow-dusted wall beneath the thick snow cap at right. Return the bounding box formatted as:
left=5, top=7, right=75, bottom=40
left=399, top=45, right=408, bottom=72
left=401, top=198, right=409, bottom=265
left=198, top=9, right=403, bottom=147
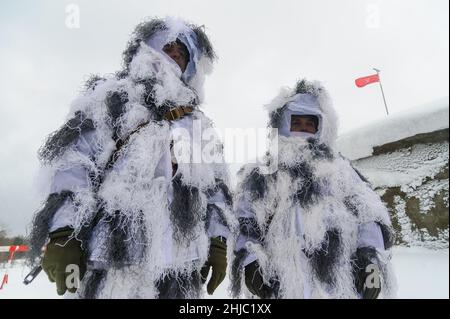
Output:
left=353, top=129, right=449, bottom=249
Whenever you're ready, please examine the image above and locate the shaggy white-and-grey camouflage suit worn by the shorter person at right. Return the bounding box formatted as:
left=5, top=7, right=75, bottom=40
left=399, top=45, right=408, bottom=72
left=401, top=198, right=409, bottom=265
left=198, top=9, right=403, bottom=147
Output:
left=232, top=80, right=395, bottom=298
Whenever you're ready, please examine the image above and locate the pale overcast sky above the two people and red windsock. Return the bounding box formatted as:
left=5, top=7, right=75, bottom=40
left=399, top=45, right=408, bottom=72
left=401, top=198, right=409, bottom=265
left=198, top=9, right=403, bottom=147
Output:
left=0, top=0, right=449, bottom=234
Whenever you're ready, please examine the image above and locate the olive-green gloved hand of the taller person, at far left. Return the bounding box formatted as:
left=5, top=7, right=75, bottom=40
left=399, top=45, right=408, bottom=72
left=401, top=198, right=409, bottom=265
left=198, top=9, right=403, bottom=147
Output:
left=42, top=228, right=86, bottom=296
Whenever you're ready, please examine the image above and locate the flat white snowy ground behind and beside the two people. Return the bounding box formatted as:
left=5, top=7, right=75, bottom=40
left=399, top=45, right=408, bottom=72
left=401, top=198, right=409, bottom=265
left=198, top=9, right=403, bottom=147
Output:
left=0, top=247, right=449, bottom=299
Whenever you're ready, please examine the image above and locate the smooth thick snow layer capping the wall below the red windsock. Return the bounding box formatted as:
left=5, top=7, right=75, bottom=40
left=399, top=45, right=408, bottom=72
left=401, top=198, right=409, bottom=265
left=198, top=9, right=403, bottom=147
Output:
left=337, top=96, right=449, bottom=160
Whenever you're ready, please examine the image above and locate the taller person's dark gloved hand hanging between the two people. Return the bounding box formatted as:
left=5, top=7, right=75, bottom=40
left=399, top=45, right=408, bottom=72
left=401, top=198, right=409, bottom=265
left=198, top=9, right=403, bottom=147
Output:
left=200, top=237, right=227, bottom=295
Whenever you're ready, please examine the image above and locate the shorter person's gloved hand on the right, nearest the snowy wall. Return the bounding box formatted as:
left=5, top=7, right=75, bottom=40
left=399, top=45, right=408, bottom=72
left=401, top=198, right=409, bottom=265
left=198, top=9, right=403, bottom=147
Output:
left=353, top=247, right=381, bottom=299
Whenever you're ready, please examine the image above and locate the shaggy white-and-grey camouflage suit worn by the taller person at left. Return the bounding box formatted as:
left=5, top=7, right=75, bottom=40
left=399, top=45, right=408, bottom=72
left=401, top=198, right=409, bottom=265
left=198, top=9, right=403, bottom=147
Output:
left=26, top=18, right=233, bottom=298
